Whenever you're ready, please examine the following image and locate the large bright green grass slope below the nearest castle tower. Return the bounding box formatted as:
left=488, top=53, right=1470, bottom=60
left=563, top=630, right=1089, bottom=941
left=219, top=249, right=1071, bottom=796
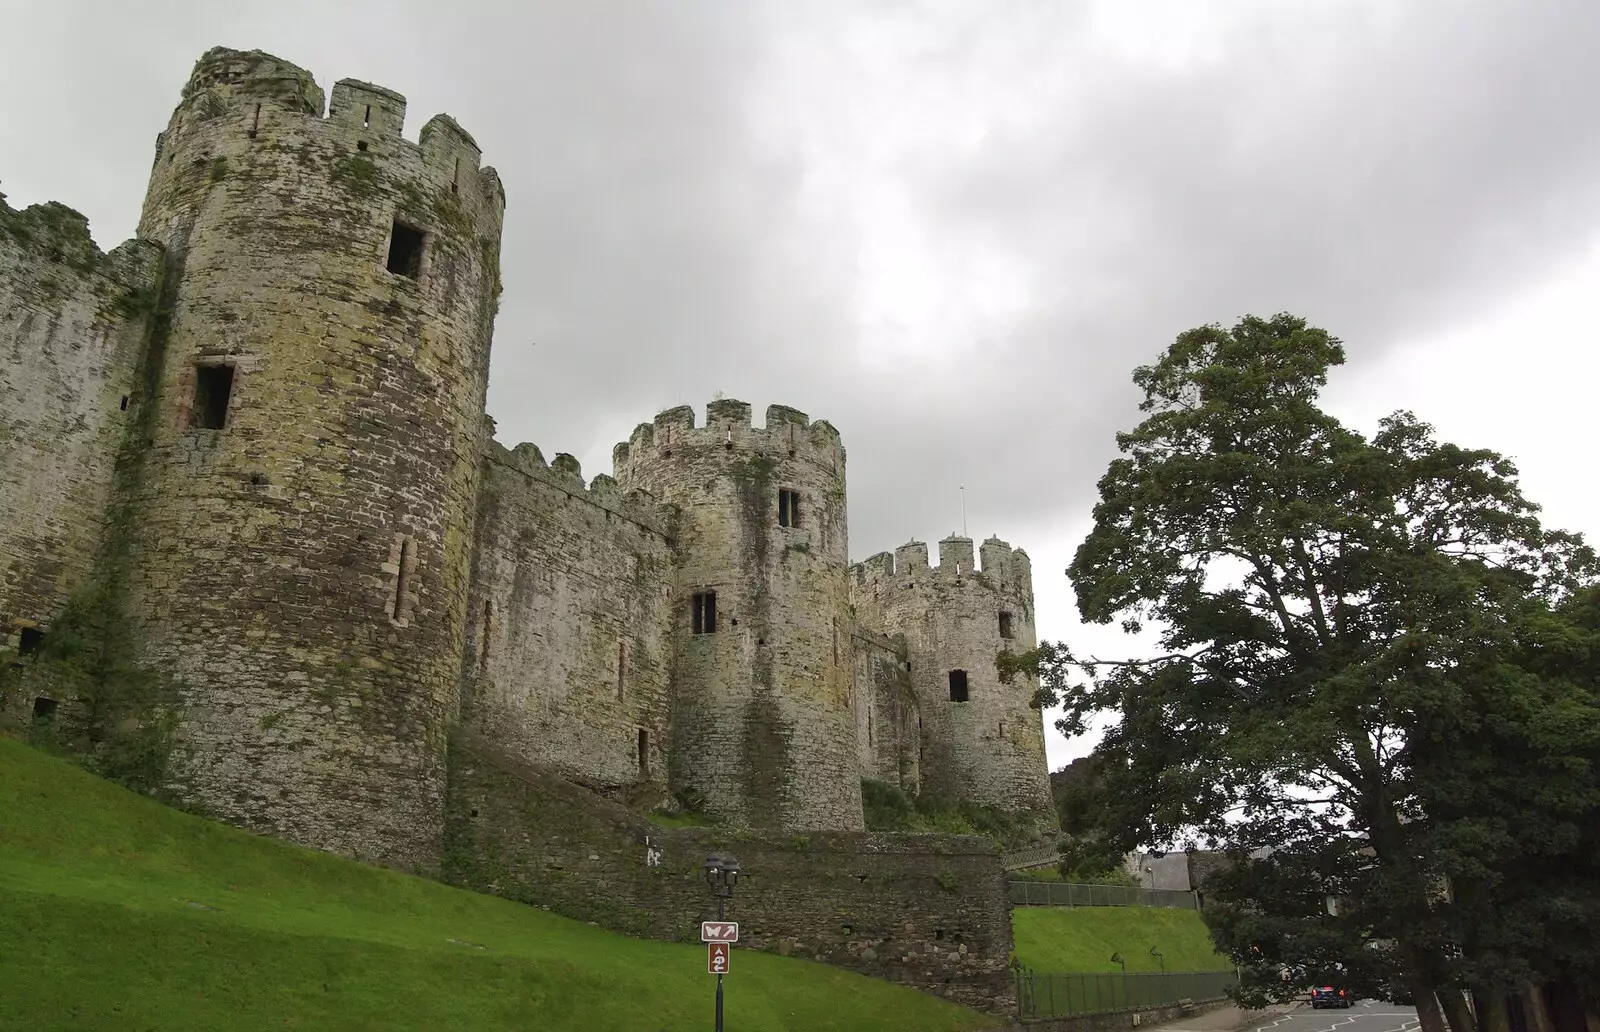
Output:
left=0, top=738, right=998, bottom=1032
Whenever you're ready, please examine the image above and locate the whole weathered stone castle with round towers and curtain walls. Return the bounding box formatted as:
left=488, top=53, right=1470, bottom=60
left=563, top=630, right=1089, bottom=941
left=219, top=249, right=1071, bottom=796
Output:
left=0, top=48, right=1054, bottom=870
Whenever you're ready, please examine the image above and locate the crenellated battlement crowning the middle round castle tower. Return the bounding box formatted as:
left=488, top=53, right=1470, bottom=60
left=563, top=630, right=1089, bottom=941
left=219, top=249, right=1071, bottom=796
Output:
left=611, top=398, right=845, bottom=478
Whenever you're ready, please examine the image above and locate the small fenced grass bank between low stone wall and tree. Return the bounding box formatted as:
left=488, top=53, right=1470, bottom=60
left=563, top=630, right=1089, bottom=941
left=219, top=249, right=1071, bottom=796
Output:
left=1011, top=907, right=1234, bottom=971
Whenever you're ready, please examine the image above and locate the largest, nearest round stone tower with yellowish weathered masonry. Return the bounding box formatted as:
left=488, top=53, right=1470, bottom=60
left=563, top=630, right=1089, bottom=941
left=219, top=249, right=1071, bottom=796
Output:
left=120, top=48, right=506, bottom=869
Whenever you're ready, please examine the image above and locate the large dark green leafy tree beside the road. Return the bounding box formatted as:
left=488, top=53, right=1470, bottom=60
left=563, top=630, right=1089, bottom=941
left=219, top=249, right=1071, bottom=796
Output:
left=1000, top=315, right=1595, bottom=1032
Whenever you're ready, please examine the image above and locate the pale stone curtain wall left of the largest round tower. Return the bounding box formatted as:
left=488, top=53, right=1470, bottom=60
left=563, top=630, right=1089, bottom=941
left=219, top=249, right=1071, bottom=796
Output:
left=0, top=198, right=162, bottom=684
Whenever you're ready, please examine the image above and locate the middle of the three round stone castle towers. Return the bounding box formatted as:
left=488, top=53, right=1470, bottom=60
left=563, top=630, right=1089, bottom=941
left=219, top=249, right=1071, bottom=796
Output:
left=613, top=402, right=862, bottom=829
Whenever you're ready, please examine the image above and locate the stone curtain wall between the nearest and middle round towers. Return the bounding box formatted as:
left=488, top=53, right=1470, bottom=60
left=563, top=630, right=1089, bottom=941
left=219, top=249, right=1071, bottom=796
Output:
left=462, top=445, right=672, bottom=795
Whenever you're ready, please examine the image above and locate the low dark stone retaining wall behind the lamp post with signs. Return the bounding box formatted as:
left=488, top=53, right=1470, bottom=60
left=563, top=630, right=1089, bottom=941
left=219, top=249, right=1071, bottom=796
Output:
left=445, top=734, right=1016, bottom=1013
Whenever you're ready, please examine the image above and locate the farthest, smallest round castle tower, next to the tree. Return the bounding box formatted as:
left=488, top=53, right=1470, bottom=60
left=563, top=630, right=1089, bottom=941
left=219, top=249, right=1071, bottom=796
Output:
left=851, top=534, right=1056, bottom=824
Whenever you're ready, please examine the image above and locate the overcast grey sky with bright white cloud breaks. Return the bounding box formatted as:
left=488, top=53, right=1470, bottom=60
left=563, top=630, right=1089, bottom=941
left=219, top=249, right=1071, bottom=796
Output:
left=0, top=0, right=1600, bottom=765
